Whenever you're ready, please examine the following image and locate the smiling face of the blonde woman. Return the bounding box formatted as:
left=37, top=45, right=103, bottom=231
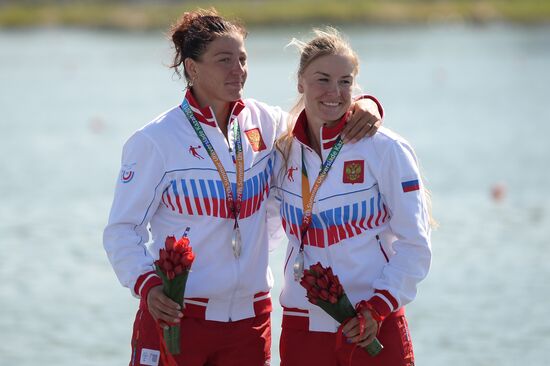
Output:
left=298, top=54, right=356, bottom=128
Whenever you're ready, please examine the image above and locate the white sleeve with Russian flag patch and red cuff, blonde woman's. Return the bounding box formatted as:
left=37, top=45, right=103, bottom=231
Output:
left=367, top=142, right=431, bottom=318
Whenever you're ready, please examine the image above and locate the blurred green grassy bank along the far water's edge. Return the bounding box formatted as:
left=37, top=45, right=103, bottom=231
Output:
left=0, top=0, right=550, bottom=30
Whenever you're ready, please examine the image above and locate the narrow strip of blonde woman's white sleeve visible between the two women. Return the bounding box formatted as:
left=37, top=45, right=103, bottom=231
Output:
left=266, top=149, right=285, bottom=251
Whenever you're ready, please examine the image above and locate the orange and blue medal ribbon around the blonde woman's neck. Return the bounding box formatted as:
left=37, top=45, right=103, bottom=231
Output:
left=300, top=136, right=344, bottom=252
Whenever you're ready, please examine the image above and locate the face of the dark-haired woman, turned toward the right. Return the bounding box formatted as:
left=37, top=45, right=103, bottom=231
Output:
left=185, top=33, right=248, bottom=107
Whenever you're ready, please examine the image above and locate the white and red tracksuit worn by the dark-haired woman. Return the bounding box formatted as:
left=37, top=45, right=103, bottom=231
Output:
left=104, top=91, right=286, bottom=365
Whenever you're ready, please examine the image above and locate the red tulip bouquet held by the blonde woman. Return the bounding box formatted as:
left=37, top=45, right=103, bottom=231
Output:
left=300, top=262, right=383, bottom=356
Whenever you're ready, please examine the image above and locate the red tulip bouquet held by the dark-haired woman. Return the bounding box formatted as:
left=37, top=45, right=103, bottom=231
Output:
left=155, top=232, right=195, bottom=355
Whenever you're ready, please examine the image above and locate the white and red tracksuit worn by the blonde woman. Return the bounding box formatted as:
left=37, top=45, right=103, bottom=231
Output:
left=272, top=112, right=431, bottom=365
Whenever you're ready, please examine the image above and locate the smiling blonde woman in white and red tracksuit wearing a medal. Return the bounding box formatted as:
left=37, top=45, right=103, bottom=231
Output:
left=273, top=29, right=431, bottom=366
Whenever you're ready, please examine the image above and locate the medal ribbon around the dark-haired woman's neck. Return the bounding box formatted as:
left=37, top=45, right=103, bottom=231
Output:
left=180, top=99, right=244, bottom=219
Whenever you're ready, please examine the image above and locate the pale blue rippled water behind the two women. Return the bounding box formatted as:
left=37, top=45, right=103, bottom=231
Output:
left=0, top=25, right=550, bottom=366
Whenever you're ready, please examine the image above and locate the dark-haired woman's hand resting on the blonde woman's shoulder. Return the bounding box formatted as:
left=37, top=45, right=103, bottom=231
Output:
left=342, top=98, right=382, bottom=143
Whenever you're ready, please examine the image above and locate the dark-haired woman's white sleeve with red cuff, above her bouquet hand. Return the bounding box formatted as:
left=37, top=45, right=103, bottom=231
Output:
left=103, top=132, right=165, bottom=298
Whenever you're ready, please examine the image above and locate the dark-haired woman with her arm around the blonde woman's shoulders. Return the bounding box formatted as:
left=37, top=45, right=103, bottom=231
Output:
left=104, top=10, right=379, bottom=366
